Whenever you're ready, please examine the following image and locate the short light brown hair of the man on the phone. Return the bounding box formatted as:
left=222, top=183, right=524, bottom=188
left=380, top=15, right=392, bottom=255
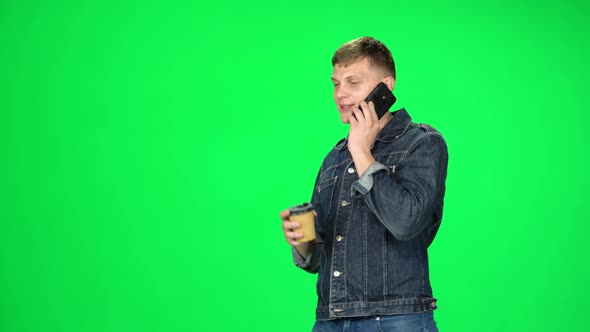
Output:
left=332, top=37, right=395, bottom=79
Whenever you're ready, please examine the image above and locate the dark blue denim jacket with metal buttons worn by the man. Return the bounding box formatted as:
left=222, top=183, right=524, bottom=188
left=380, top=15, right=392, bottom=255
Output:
left=293, top=108, right=448, bottom=320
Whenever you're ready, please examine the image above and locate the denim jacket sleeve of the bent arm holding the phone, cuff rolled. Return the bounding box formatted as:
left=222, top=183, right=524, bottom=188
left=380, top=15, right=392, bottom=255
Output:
left=352, top=134, right=448, bottom=240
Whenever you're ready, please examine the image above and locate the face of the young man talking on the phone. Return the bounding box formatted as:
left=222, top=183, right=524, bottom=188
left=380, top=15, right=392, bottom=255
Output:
left=332, top=58, right=384, bottom=123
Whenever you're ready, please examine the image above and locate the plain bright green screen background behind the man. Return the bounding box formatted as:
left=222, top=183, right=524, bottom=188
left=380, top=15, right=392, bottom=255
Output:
left=0, top=0, right=590, bottom=332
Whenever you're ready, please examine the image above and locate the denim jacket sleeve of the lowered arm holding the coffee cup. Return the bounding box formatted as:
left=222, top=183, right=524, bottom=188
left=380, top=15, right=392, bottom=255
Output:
left=291, top=167, right=325, bottom=273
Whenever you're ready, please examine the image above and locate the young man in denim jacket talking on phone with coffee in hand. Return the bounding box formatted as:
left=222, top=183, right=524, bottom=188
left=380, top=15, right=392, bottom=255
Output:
left=280, top=37, right=448, bottom=332
